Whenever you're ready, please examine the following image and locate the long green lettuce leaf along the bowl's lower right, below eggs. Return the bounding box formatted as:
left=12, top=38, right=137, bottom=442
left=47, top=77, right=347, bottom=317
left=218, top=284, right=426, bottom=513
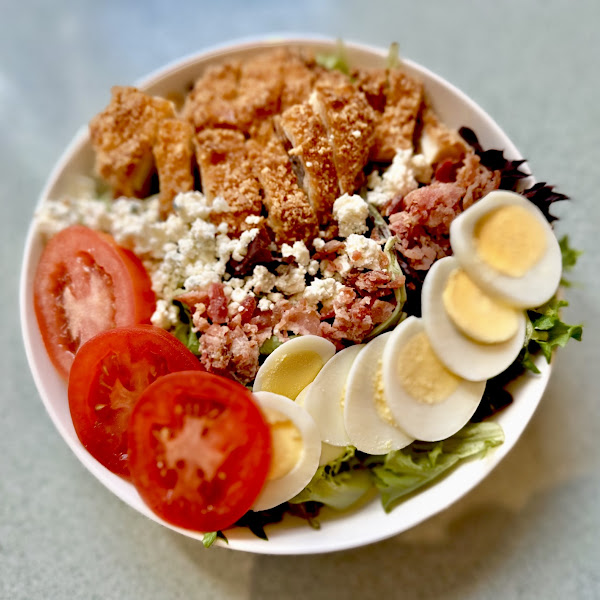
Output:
left=366, top=421, right=504, bottom=512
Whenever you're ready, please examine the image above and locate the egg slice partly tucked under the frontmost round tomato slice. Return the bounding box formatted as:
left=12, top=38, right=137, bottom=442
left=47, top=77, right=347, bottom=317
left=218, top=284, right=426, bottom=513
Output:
left=252, top=392, right=321, bottom=510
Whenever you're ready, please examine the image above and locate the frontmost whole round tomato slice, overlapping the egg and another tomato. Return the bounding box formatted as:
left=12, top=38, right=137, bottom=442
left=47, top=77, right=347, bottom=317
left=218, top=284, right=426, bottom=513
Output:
left=129, top=371, right=271, bottom=531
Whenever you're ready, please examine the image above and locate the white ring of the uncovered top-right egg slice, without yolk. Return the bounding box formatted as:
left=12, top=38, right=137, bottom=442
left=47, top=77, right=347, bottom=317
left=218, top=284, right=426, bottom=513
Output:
left=450, top=190, right=562, bottom=308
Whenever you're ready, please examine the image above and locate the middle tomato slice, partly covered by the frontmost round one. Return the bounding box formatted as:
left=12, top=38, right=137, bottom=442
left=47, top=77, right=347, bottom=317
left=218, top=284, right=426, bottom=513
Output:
left=68, top=325, right=203, bottom=477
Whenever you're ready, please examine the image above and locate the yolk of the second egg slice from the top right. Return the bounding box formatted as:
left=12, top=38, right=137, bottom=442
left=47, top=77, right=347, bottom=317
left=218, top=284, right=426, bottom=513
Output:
left=442, top=269, right=519, bottom=344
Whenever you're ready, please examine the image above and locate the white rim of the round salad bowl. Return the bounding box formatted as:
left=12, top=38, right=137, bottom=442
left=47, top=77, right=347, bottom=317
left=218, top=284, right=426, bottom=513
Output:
left=19, top=33, right=551, bottom=555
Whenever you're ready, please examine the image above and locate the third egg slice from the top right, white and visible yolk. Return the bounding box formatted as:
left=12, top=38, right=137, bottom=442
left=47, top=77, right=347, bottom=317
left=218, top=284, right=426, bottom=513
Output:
left=383, top=317, right=485, bottom=442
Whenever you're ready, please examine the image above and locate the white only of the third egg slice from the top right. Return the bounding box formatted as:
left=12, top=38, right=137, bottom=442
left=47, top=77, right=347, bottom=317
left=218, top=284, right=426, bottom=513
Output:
left=383, top=317, right=485, bottom=442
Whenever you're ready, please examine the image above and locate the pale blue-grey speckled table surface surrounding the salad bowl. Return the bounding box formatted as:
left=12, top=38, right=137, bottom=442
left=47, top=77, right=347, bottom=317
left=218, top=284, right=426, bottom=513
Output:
left=0, top=0, right=600, bottom=600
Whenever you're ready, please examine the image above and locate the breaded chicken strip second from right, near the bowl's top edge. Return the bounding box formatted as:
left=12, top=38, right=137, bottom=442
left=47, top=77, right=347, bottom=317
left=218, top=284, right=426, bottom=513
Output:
left=371, top=69, right=423, bottom=162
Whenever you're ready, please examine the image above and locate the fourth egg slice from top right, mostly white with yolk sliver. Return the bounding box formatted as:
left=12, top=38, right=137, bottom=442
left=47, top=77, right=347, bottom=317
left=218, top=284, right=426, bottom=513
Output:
left=344, top=333, right=414, bottom=454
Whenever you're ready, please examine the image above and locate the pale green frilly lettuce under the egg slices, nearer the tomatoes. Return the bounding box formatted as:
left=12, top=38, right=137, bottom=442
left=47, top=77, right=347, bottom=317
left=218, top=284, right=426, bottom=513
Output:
left=290, top=446, right=373, bottom=510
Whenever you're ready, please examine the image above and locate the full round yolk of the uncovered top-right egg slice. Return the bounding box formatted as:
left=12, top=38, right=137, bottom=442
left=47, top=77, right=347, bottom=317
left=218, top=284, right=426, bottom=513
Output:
left=474, top=204, right=547, bottom=277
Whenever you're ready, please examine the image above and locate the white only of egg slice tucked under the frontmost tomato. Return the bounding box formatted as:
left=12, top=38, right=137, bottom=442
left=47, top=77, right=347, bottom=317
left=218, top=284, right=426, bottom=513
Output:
left=252, top=392, right=321, bottom=511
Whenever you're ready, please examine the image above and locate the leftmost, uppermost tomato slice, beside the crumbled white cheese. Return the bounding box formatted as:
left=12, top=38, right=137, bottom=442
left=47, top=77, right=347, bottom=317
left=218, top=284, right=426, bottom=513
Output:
left=33, top=225, right=155, bottom=379
